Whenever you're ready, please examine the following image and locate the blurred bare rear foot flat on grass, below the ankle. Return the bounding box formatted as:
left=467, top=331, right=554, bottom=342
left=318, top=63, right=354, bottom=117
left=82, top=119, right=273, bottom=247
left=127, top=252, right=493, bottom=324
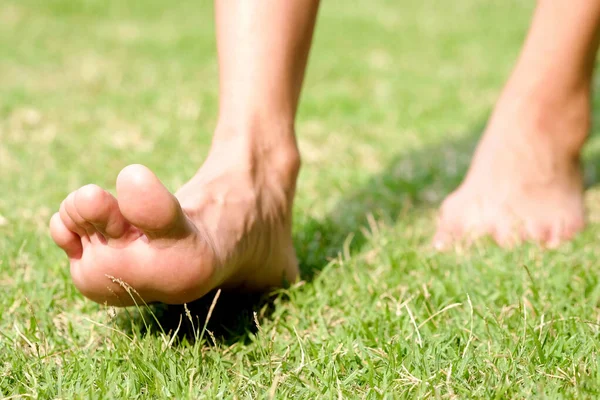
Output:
left=434, top=89, right=590, bottom=249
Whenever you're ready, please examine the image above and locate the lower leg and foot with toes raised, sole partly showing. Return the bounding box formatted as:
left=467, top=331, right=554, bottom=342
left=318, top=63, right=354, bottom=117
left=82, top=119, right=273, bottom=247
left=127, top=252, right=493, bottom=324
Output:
left=50, top=0, right=318, bottom=306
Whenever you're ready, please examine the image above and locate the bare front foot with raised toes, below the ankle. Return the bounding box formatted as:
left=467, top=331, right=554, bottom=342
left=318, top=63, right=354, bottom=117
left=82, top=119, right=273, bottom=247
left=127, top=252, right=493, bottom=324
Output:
left=50, top=133, right=299, bottom=306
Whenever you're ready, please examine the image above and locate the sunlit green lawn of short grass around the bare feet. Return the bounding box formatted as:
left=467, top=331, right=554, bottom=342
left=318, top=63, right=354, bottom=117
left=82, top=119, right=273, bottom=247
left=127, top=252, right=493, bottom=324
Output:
left=0, top=0, right=600, bottom=399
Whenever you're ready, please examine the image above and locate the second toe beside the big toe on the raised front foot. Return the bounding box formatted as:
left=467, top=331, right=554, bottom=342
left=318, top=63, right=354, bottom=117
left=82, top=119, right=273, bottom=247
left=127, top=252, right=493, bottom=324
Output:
left=73, top=185, right=130, bottom=238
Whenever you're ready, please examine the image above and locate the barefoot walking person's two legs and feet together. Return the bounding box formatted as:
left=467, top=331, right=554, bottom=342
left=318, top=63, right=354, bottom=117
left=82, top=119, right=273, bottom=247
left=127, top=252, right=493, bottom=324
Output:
left=50, top=0, right=600, bottom=306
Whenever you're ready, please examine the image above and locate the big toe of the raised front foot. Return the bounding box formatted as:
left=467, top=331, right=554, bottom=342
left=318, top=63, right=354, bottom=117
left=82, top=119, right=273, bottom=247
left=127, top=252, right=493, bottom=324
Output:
left=117, top=164, right=190, bottom=239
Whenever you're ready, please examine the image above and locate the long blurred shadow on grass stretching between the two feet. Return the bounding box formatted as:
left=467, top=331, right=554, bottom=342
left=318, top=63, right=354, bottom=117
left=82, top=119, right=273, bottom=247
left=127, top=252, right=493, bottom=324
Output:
left=295, top=123, right=484, bottom=281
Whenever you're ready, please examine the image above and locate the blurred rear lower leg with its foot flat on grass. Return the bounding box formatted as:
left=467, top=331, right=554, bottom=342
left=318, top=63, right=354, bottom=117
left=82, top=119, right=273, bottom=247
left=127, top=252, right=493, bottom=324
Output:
left=434, top=0, right=600, bottom=248
